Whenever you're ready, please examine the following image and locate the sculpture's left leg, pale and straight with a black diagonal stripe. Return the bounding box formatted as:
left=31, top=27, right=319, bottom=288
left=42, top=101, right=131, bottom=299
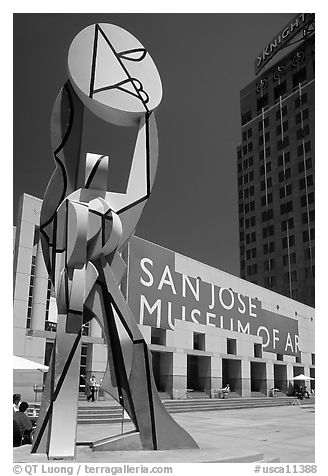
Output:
left=32, top=269, right=84, bottom=459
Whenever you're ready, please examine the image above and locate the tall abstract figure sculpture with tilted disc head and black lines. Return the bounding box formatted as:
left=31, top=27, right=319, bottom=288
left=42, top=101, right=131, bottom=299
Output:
left=32, top=24, right=198, bottom=458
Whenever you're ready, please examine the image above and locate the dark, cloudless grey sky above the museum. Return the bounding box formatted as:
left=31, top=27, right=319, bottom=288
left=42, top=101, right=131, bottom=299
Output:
left=13, top=13, right=295, bottom=276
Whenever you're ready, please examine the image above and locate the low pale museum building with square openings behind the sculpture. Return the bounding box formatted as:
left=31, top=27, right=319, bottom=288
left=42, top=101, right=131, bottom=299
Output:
left=13, top=194, right=315, bottom=401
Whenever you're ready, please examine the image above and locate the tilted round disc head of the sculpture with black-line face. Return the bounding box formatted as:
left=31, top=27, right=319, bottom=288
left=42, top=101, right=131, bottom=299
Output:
left=68, top=23, right=162, bottom=126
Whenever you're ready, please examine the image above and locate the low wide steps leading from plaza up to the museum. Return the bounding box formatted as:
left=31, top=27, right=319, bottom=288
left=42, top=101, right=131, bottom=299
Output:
left=29, top=392, right=315, bottom=424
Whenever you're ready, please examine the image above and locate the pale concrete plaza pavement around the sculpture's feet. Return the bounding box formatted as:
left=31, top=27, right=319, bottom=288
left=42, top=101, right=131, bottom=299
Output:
left=14, top=405, right=315, bottom=463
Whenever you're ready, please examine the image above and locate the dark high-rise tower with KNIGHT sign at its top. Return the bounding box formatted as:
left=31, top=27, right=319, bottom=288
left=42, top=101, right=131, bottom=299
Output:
left=237, top=13, right=315, bottom=306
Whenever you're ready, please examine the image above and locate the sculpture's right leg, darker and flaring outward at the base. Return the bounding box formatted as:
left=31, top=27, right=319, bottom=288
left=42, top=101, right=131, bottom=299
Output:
left=92, top=260, right=198, bottom=450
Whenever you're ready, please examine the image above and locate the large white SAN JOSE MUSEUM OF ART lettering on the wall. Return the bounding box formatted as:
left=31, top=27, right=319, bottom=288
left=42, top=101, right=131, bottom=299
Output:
left=128, top=237, right=299, bottom=355
